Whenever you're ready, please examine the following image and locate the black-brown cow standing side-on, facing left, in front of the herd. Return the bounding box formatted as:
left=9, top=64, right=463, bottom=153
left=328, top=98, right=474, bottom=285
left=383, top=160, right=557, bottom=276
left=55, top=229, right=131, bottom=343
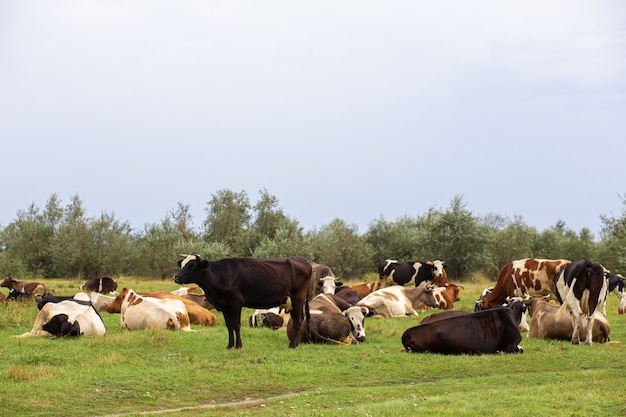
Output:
left=174, top=254, right=312, bottom=349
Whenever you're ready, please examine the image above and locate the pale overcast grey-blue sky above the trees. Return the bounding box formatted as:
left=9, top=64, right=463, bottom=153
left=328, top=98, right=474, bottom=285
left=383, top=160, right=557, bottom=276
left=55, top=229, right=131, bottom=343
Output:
left=0, top=0, right=626, bottom=237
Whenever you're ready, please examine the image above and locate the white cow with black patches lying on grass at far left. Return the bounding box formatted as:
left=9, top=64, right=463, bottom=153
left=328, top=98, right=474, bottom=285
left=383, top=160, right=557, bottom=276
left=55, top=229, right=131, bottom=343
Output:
left=16, top=300, right=106, bottom=337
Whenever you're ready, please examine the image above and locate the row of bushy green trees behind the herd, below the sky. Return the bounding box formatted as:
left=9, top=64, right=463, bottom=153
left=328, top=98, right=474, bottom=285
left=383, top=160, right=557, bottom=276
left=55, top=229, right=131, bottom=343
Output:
left=0, top=189, right=626, bottom=281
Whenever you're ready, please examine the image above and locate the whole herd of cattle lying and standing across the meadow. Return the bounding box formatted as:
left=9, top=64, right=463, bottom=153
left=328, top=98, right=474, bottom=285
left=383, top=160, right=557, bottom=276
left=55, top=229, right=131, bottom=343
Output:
left=0, top=254, right=626, bottom=354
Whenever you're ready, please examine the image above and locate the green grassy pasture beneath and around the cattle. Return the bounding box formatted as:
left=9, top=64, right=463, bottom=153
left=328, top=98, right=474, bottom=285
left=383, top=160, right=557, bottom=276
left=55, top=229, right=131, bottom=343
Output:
left=0, top=278, right=626, bottom=417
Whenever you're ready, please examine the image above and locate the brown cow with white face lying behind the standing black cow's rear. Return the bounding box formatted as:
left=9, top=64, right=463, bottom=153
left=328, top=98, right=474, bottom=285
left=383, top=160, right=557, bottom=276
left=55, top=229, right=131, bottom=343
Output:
left=287, top=294, right=371, bottom=344
